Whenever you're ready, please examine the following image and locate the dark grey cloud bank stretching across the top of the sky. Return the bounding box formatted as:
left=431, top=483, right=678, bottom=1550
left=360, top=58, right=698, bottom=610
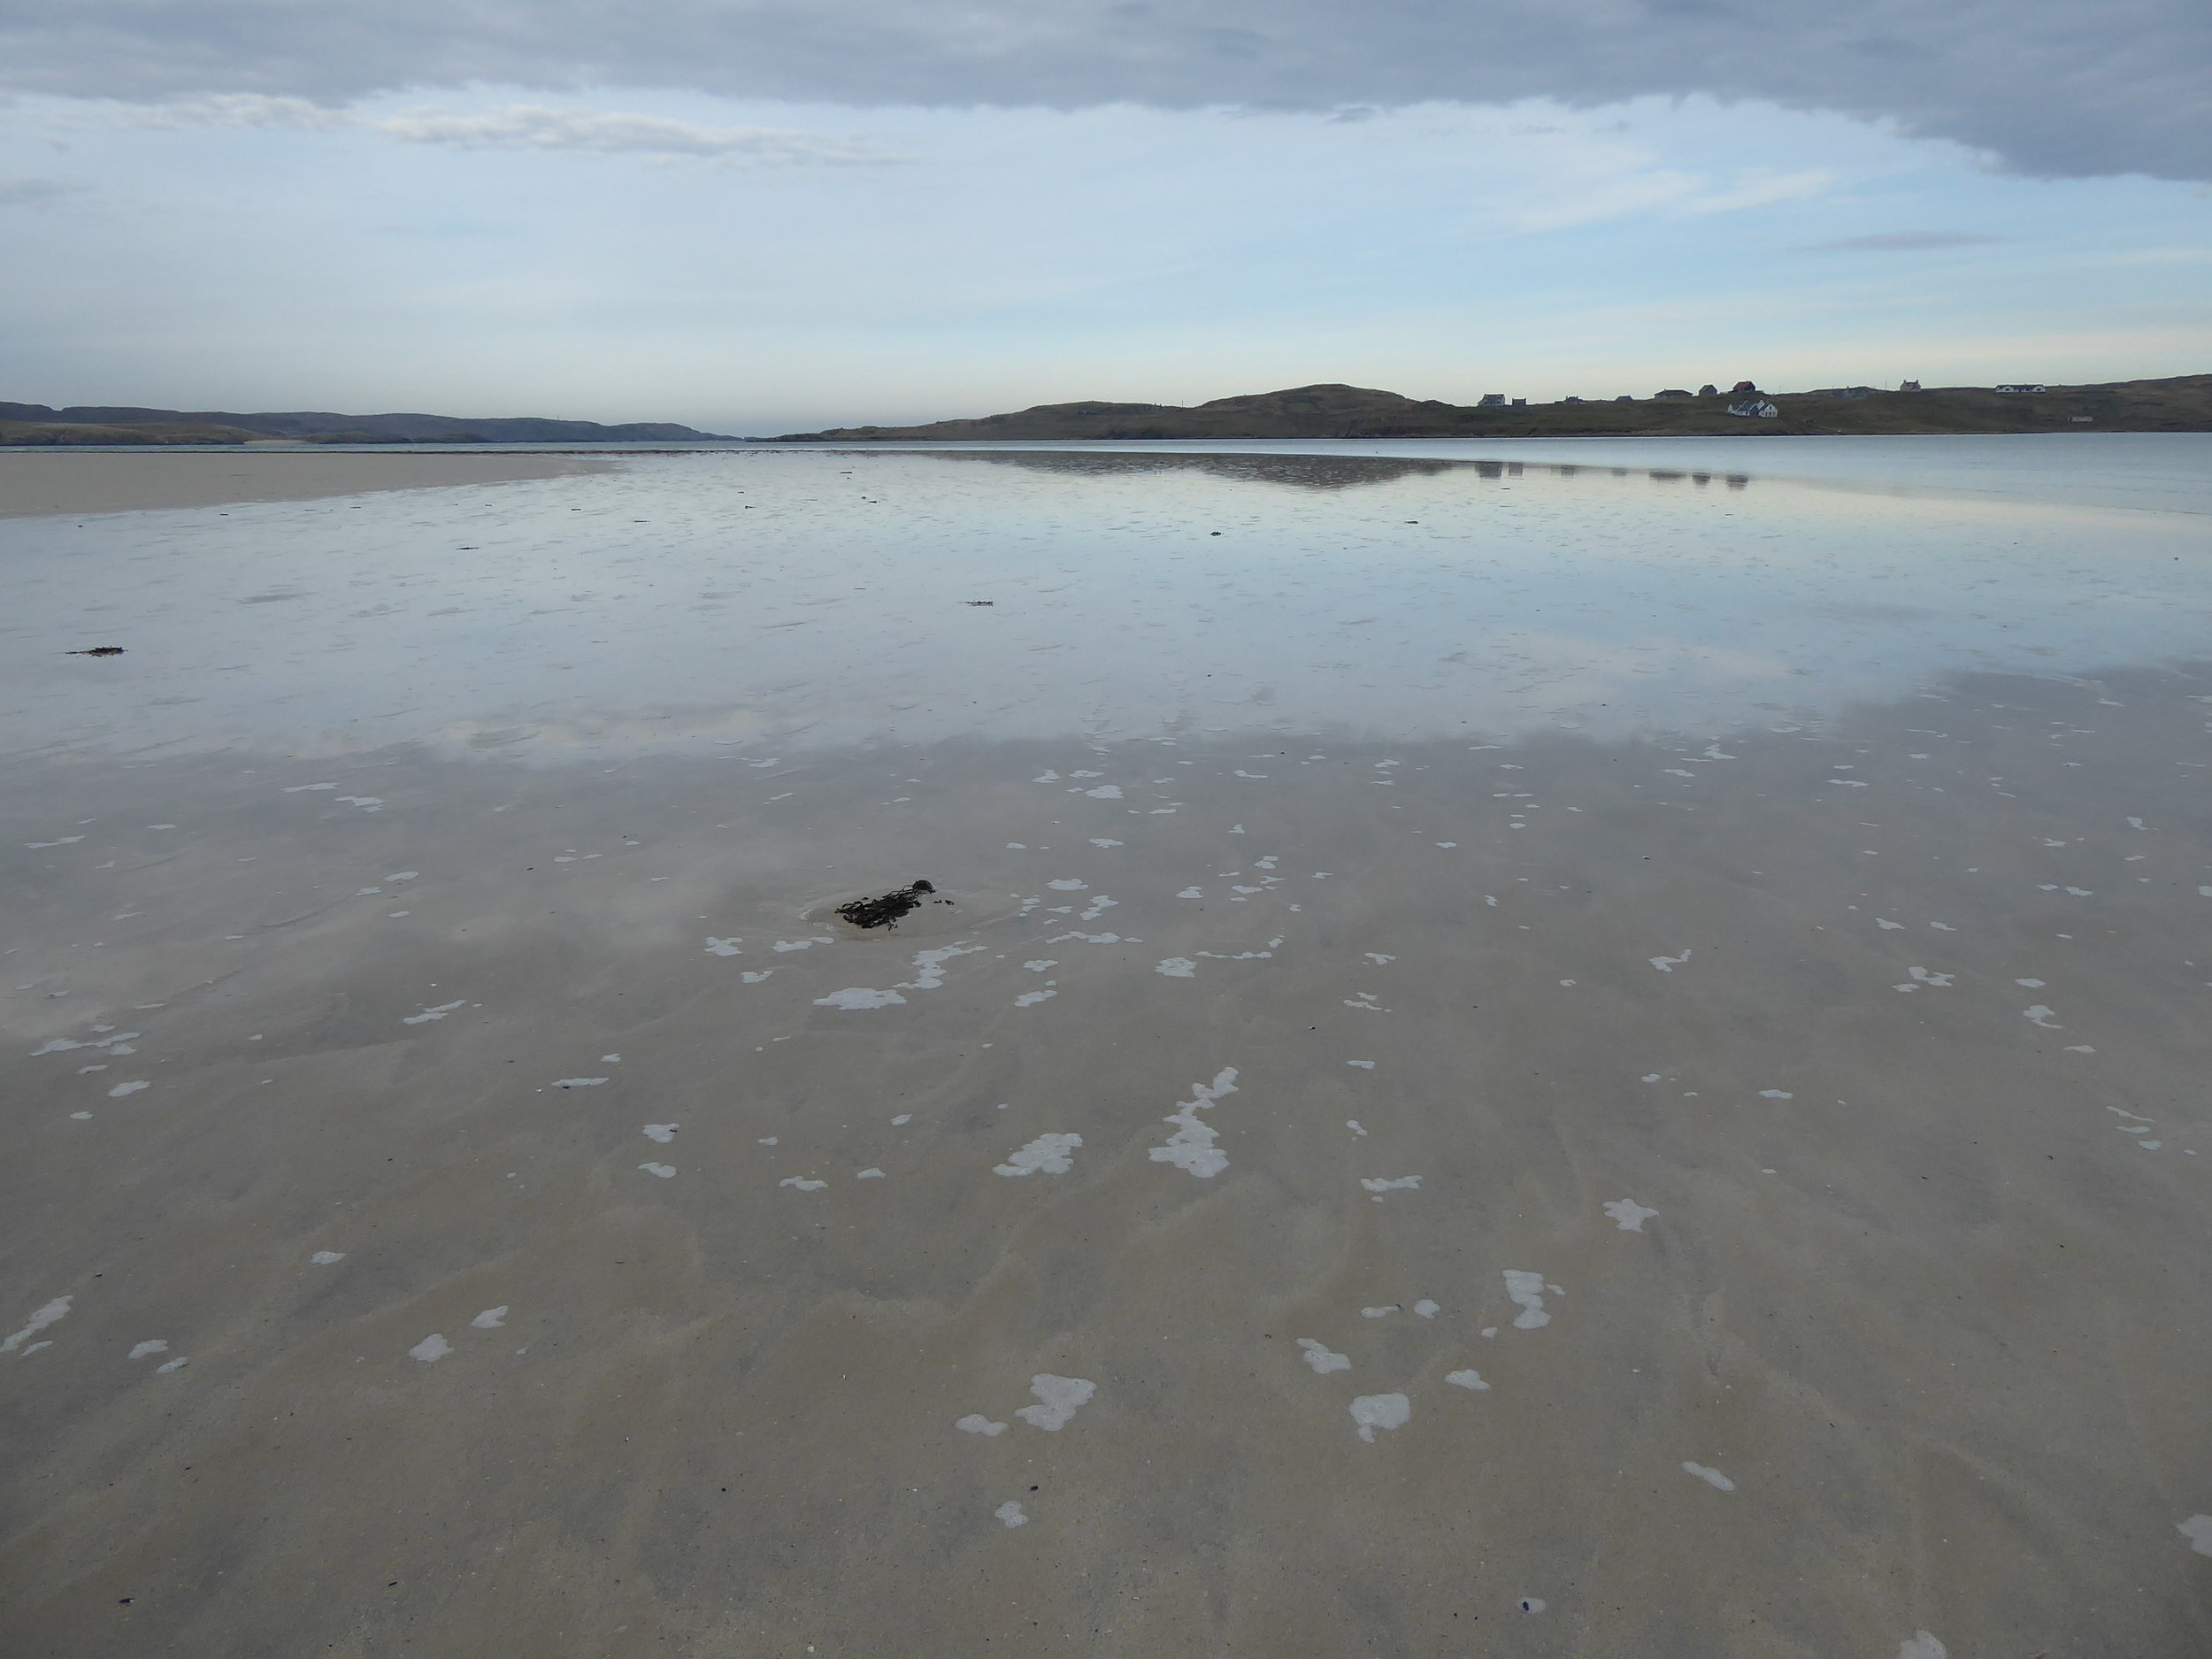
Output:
left=0, top=0, right=2212, bottom=180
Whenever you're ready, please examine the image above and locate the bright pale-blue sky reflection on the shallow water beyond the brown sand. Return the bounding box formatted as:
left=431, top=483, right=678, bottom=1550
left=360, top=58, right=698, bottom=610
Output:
left=0, top=449, right=2212, bottom=761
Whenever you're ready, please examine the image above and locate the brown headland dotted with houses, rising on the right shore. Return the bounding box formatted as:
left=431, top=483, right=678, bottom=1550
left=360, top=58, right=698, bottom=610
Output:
left=777, top=374, right=2212, bottom=442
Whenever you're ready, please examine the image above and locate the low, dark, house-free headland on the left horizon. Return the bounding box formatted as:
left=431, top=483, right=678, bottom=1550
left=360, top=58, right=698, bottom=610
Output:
left=0, top=403, right=743, bottom=447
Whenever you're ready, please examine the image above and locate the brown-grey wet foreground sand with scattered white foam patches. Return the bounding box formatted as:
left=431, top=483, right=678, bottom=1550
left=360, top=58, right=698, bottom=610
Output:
left=0, top=444, right=2212, bottom=1659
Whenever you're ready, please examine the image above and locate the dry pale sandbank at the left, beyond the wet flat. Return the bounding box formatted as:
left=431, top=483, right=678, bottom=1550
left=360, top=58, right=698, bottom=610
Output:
left=0, top=447, right=611, bottom=518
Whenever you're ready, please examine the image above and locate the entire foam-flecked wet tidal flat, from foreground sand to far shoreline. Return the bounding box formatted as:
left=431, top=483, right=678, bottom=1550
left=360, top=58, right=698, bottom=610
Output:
left=0, top=438, right=2212, bottom=1659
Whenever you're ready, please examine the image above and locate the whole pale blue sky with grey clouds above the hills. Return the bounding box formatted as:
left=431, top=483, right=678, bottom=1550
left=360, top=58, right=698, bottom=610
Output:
left=0, top=0, right=2212, bottom=434
